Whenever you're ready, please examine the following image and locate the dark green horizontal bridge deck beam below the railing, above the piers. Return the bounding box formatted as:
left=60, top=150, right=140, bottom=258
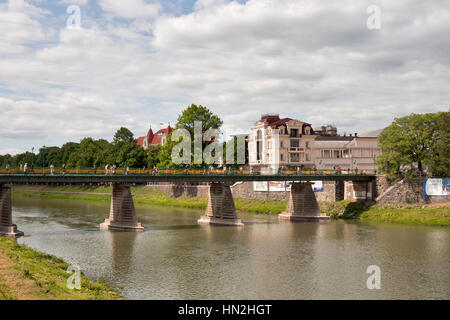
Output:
left=0, top=174, right=375, bottom=184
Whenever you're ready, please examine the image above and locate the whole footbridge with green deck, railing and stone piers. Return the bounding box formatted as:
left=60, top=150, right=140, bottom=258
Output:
left=0, top=169, right=376, bottom=238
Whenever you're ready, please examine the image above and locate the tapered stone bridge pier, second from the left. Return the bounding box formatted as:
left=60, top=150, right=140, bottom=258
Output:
left=100, top=184, right=144, bottom=231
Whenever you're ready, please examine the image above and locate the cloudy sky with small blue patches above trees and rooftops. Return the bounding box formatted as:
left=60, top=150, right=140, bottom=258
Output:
left=0, top=0, right=450, bottom=154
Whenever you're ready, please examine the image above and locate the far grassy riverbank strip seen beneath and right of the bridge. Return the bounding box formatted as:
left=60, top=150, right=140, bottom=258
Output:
left=13, top=186, right=450, bottom=226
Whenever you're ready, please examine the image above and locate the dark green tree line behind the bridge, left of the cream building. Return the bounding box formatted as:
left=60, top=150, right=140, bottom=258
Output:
left=0, top=104, right=248, bottom=168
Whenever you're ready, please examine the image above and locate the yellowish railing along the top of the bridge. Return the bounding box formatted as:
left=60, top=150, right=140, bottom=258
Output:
left=0, top=167, right=375, bottom=176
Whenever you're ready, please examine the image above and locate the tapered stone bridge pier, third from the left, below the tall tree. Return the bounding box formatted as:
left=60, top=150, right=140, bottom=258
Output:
left=198, top=182, right=244, bottom=226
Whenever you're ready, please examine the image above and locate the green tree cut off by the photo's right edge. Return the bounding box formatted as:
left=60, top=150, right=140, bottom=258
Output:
left=425, top=112, right=450, bottom=177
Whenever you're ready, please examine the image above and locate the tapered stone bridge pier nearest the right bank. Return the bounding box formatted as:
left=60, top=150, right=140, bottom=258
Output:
left=278, top=182, right=330, bottom=221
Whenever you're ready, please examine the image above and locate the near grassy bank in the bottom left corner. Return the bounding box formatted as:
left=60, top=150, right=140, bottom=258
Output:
left=0, top=237, right=123, bottom=300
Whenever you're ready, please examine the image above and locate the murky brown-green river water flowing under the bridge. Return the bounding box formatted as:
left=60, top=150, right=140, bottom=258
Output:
left=13, top=196, right=450, bottom=299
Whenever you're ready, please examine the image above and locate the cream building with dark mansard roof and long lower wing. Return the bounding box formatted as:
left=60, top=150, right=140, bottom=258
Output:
left=248, top=114, right=382, bottom=171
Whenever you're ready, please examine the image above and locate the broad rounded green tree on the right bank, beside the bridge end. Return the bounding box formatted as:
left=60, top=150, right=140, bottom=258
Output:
left=376, top=113, right=438, bottom=179
